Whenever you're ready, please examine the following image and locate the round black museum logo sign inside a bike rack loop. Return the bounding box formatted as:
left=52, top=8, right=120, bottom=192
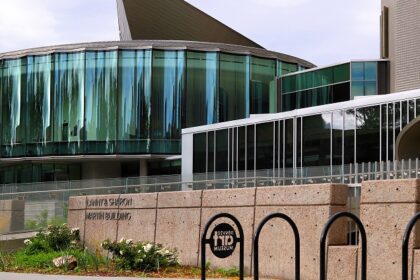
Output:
left=210, top=223, right=236, bottom=259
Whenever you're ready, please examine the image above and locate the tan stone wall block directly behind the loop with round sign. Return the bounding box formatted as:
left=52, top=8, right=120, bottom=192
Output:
left=200, top=207, right=254, bottom=273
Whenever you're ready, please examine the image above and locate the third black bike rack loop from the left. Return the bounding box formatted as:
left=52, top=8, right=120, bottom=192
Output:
left=319, top=212, right=367, bottom=280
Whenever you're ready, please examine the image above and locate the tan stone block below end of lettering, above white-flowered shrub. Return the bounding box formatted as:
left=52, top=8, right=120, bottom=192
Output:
left=117, top=209, right=156, bottom=242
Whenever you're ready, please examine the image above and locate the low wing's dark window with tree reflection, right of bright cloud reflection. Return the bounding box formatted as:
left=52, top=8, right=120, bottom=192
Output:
left=356, top=106, right=380, bottom=163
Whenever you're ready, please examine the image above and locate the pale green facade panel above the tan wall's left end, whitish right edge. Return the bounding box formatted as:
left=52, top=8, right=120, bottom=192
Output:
left=53, top=53, right=85, bottom=154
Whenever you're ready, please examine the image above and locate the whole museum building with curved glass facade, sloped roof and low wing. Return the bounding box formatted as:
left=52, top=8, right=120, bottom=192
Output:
left=0, top=0, right=420, bottom=184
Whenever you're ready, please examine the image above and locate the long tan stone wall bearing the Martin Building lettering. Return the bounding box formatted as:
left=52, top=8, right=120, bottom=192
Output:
left=69, top=184, right=348, bottom=279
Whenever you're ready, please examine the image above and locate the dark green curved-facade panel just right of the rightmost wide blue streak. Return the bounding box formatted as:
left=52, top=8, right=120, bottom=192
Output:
left=218, top=53, right=250, bottom=122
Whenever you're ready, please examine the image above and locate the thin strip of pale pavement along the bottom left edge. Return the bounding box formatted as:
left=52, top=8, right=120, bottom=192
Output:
left=0, top=272, right=192, bottom=280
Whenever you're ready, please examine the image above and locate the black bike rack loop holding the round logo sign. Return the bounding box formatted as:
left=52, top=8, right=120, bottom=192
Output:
left=201, top=213, right=245, bottom=280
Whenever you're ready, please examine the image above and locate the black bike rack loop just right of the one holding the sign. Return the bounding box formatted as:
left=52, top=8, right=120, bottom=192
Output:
left=253, top=213, right=300, bottom=280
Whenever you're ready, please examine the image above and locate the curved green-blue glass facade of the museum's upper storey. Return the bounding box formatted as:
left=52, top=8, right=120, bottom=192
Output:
left=0, top=49, right=300, bottom=158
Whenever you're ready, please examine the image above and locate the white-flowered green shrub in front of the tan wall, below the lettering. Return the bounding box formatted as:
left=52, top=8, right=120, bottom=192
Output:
left=101, top=238, right=179, bottom=271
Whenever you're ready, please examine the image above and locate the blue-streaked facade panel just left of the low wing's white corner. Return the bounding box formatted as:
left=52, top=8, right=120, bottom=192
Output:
left=150, top=51, right=185, bottom=154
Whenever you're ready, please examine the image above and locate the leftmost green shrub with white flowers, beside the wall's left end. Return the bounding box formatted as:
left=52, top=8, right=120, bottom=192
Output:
left=24, top=224, right=80, bottom=255
